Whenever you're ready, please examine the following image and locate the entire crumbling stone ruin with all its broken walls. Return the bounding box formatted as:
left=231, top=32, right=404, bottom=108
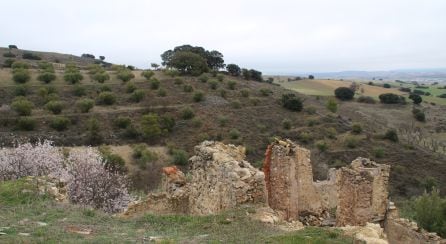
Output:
left=124, top=140, right=445, bottom=243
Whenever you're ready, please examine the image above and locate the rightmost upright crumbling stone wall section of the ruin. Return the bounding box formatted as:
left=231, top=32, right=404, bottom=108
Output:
left=336, top=158, right=390, bottom=226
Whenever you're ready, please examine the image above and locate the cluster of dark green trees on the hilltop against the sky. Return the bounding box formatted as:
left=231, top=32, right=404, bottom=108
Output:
left=161, top=45, right=263, bottom=81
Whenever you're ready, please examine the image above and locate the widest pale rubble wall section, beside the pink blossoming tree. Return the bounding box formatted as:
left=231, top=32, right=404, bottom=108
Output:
left=188, top=141, right=266, bottom=214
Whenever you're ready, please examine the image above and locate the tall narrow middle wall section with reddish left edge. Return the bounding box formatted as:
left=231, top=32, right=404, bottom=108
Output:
left=264, top=140, right=324, bottom=220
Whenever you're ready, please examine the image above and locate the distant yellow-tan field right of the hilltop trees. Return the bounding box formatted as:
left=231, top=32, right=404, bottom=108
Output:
left=279, top=79, right=403, bottom=98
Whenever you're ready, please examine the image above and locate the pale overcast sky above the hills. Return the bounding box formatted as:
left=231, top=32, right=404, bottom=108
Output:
left=0, top=0, right=446, bottom=74
